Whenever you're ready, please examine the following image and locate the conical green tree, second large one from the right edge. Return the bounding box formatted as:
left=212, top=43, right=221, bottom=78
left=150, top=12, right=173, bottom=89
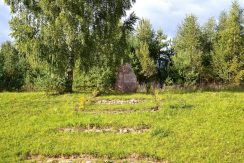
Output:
left=173, top=15, right=203, bottom=84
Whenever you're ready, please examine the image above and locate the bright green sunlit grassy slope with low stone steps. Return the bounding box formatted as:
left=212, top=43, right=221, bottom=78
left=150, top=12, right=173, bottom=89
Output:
left=0, top=91, right=244, bottom=162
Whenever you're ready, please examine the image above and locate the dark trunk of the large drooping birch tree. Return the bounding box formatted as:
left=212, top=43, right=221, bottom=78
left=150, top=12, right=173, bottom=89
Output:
left=64, top=52, right=75, bottom=93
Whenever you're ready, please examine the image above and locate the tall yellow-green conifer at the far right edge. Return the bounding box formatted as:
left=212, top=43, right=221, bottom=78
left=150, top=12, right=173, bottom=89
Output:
left=213, top=2, right=243, bottom=85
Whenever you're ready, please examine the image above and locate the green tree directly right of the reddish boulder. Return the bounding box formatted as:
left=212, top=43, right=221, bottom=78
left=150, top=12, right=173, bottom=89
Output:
left=129, top=19, right=168, bottom=87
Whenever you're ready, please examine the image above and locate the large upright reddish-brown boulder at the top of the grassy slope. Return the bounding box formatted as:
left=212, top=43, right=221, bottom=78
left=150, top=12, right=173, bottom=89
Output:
left=115, top=63, right=138, bottom=93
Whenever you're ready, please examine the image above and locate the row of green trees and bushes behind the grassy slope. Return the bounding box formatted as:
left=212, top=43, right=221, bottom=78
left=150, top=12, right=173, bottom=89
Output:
left=0, top=0, right=244, bottom=93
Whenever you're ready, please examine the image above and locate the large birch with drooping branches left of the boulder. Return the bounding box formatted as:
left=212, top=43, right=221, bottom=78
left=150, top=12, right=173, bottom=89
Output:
left=5, top=0, right=135, bottom=92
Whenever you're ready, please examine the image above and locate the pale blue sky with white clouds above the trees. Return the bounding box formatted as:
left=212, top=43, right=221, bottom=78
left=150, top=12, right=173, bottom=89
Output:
left=0, top=0, right=244, bottom=43
